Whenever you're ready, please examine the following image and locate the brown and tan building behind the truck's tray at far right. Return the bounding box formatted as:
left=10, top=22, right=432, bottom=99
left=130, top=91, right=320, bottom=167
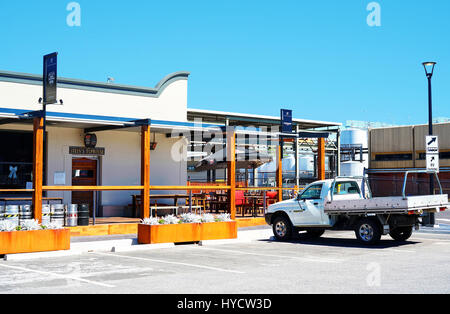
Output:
left=369, top=123, right=450, bottom=196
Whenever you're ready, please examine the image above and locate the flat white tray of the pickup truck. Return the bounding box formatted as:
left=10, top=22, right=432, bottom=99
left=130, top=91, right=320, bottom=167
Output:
left=324, top=194, right=448, bottom=215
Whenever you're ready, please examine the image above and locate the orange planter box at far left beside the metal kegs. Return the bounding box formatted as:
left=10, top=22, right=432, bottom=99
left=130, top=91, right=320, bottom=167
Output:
left=0, top=229, right=70, bottom=255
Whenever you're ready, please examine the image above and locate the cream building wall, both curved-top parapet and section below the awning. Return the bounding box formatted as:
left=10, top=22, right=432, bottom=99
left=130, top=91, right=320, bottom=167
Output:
left=0, top=72, right=189, bottom=216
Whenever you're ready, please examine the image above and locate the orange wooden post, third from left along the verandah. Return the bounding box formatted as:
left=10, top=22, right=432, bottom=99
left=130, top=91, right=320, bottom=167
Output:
left=227, top=128, right=236, bottom=220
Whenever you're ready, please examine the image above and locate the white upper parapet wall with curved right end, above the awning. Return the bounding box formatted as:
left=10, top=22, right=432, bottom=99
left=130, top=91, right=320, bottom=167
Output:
left=0, top=73, right=188, bottom=122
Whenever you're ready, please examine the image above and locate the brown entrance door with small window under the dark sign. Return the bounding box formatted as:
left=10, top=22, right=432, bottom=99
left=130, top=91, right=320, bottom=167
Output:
left=72, top=158, right=97, bottom=217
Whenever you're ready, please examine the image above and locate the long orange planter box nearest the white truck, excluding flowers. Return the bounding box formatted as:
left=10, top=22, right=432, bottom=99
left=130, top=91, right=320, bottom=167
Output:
left=138, top=221, right=237, bottom=244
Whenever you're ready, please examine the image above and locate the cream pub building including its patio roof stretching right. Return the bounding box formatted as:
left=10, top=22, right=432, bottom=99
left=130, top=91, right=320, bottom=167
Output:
left=0, top=71, right=340, bottom=217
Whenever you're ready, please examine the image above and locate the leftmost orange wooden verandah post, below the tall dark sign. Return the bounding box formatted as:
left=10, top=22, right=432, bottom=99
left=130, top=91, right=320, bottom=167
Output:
left=33, top=117, right=44, bottom=223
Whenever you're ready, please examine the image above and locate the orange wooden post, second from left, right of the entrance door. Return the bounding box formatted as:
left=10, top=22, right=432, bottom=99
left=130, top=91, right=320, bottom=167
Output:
left=141, top=125, right=150, bottom=219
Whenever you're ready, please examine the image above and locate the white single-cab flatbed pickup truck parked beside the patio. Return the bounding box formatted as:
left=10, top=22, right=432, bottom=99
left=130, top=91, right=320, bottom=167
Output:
left=265, top=171, right=449, bottom=244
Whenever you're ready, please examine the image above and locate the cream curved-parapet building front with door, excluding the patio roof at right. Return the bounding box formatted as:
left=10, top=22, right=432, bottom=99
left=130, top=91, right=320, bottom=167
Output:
left=0, top=72, right=189, bottom=216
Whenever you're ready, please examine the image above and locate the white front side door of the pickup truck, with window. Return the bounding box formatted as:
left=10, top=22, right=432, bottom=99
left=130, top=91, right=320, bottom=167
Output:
left=292, top=184, right=324, bottom=226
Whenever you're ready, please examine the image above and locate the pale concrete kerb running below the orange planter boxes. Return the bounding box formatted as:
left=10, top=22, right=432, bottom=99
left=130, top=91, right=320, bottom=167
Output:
left=4, top=229, right=272, bottom=261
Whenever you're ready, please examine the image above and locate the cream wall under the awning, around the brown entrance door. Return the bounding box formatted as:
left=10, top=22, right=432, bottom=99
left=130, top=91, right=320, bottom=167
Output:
left=0, top=124, right=187, bottom=215
